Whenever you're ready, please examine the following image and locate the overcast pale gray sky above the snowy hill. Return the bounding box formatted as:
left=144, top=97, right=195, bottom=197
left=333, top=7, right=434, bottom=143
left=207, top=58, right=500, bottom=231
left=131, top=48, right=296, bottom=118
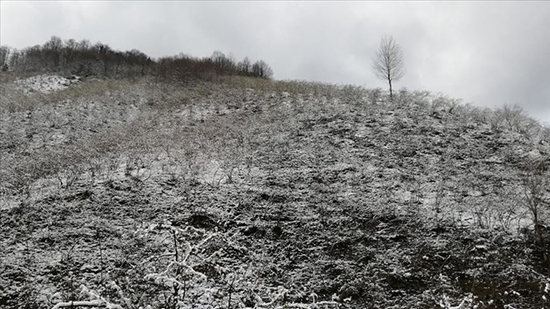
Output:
left=0, top=0, right=550, bottom=123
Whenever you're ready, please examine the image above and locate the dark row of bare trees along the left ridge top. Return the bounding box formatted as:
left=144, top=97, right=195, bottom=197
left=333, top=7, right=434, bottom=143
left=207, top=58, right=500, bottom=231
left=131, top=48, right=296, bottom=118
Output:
left=0, top=36, right=273, bottom=80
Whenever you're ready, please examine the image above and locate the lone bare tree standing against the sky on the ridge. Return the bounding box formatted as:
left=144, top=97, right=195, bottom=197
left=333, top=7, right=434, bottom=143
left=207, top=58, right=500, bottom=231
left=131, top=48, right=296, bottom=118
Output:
left=372, top=36, right=405, bottom=100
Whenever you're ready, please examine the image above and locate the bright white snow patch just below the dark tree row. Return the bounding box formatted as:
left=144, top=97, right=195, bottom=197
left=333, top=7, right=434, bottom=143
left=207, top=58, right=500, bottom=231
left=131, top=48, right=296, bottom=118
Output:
left=14, top=75, right=80, bottom=93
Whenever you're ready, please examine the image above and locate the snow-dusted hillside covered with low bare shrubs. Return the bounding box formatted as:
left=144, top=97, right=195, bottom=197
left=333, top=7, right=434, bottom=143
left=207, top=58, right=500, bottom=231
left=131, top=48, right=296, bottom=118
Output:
left=0, top=73, right=550, bottom=309
